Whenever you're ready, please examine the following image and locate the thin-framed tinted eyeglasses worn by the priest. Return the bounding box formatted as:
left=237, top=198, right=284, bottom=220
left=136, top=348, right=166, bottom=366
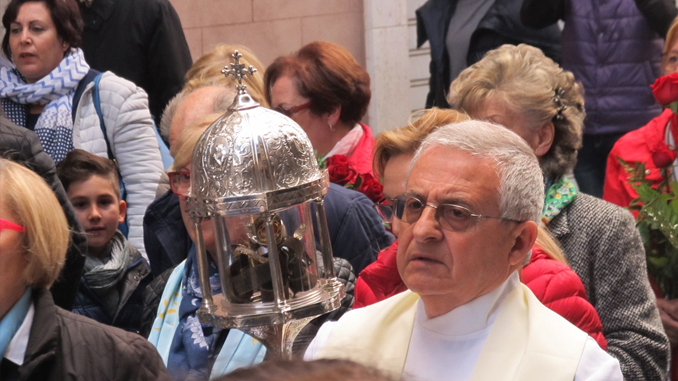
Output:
left=394, top=196, right=521, bottom=232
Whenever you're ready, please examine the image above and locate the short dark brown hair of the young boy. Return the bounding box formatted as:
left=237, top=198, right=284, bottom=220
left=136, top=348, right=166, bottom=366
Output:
left=57, top=149, right=120, bottom=199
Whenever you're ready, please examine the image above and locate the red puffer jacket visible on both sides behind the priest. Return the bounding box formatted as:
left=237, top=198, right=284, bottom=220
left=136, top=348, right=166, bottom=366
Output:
left=353, top=241, right=607, bottom=349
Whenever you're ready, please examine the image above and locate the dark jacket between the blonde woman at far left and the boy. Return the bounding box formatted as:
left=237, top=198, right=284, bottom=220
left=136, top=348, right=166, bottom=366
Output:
left=0, top=117, right=87, bottom=310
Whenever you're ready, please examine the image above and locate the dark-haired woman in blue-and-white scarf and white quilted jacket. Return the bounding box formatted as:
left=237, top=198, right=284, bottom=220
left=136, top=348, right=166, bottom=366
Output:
left=0, top=0, right=163, bottom=253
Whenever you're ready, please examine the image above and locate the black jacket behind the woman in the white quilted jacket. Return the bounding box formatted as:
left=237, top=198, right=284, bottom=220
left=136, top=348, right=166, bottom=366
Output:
left=80, top=0, right=193, bottom=124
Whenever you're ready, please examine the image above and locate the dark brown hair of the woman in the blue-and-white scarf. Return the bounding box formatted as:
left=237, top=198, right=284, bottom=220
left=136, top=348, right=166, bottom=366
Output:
left=2, top=0, right=84, bottom=60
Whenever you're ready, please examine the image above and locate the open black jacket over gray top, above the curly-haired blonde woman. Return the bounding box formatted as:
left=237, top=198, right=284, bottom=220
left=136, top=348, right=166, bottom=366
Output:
left=416, top=0, right=560, bottom=108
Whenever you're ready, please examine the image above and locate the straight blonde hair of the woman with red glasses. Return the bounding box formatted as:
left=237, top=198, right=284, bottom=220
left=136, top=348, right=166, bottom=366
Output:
left=0, top=158, right=70, bottom=288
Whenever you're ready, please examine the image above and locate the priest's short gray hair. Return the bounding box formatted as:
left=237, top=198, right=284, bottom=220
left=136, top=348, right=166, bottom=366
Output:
left=407, top=120, right=544, bottom=222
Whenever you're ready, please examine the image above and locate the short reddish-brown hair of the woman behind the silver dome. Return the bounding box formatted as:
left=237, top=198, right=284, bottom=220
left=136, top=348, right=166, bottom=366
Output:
left=264, top=41, right=372, bottom=127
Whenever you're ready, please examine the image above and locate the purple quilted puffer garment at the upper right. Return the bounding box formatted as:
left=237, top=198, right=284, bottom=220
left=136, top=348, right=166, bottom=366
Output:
left=561, top=0, right=664, bottom=134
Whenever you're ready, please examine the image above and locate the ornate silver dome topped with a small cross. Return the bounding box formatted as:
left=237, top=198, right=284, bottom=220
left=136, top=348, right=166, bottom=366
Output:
left=187, top=52, right=329, bottom=217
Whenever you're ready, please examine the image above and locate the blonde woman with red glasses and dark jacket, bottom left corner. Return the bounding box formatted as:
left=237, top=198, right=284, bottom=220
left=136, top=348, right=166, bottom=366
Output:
left=0, top=159, right=169, bottom=381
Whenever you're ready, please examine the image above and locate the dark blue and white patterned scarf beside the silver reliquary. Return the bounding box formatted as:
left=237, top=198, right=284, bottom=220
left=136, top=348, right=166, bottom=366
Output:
left=167, top=245, right=226, bottom=380
